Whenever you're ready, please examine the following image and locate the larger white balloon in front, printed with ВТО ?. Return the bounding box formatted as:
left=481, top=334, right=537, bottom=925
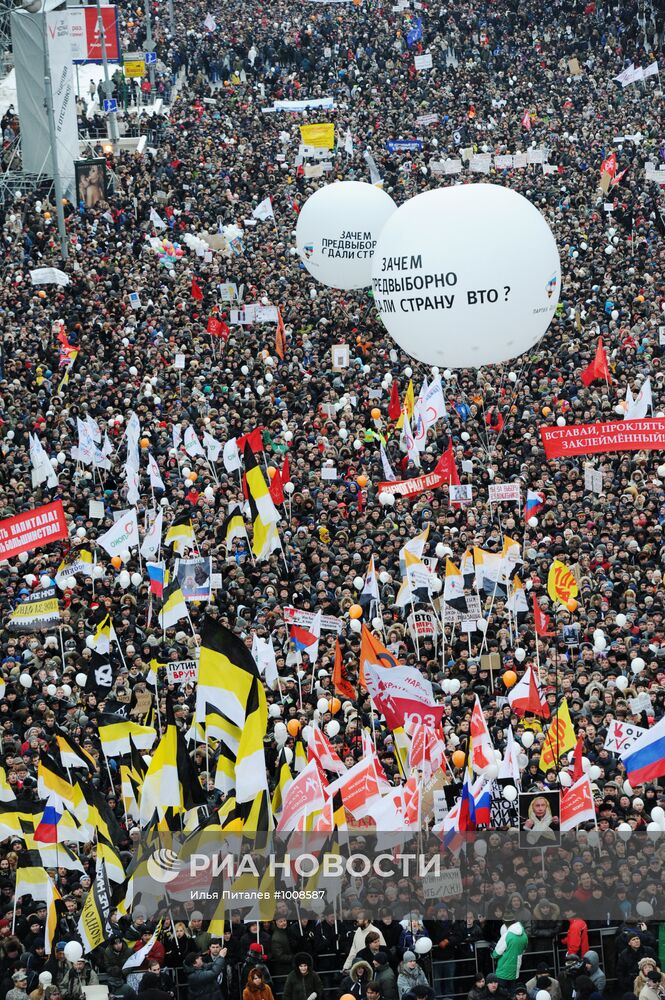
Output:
left=372, top=184, right=561, bottom=368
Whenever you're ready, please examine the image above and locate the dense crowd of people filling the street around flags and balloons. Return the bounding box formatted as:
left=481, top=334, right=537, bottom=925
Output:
left=0, top=0, right=665, bottom=1000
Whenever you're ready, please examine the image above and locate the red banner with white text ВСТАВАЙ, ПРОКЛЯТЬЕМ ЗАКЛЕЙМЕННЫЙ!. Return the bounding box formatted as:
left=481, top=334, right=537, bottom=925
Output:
left=540, top=417, right=665, bottom=458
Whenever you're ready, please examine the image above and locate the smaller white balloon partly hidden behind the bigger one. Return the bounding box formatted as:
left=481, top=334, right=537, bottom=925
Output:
left=296, top=181, right=396, bottom=288
